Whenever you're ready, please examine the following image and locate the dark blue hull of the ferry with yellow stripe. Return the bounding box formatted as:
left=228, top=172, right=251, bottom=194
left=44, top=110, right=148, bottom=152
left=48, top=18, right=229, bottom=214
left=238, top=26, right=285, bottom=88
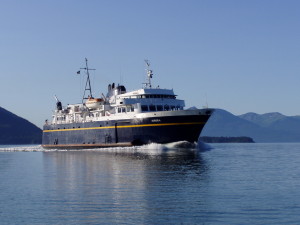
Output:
left=42, top=115, right=210, bottom=149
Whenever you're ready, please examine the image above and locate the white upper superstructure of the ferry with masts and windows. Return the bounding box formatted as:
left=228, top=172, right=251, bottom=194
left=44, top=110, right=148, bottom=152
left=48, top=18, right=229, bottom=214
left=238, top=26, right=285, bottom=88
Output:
left=47, top=60, right=185, bottom=124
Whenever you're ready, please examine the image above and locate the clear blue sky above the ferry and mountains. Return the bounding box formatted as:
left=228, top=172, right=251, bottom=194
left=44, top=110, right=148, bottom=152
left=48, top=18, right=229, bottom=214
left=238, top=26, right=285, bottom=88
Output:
left=0, top=0, right=300, bottom=127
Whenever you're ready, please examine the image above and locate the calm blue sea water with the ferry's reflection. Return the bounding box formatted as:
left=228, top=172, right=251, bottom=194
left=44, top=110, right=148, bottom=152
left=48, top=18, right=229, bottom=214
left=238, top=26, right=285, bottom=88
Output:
left=0, top=143, right=300, bottom=225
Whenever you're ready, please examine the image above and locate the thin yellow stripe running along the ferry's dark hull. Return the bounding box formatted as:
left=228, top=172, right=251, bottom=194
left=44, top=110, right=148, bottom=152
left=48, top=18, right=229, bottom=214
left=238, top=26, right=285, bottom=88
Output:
left=43, top=122, right=205, bottom=132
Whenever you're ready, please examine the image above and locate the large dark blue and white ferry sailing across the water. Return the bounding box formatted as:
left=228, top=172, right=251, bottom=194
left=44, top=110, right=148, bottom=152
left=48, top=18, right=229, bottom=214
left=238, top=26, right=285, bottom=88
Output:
left=42, top=59, right=213, bottom=149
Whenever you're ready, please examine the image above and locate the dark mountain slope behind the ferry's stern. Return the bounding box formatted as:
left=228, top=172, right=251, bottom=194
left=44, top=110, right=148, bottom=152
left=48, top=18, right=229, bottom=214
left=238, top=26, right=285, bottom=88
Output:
left=0, top=107, right=42, bottom=145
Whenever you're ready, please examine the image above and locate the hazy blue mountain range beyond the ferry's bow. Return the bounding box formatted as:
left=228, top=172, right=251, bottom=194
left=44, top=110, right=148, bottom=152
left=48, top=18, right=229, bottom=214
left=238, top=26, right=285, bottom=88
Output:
left=201, top=109, right=300, bottom=142
